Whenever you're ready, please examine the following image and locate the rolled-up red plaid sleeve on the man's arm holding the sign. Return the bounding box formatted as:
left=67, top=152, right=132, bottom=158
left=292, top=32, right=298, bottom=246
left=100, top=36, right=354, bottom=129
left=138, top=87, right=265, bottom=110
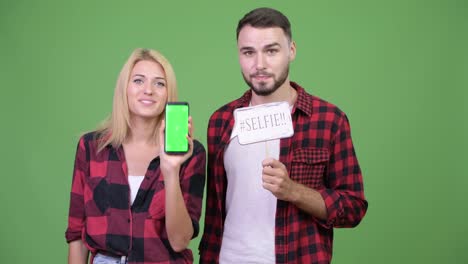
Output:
left=319, top=114, right=368, bottom=228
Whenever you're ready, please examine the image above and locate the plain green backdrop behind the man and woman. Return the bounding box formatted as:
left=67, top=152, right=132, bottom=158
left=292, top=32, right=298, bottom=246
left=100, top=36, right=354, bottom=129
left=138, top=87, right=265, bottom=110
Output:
left=0, top=0, right=468, bottom=264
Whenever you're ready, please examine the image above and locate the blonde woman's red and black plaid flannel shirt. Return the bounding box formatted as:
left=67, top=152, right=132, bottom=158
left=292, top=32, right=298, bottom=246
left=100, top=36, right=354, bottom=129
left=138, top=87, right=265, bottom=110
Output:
left=65, top=133, right=206, bottom=263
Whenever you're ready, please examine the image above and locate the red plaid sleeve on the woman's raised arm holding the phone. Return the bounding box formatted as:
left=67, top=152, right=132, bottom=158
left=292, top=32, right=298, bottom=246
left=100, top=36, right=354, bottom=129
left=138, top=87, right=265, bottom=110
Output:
left=180, top=140, right=206, bottom=238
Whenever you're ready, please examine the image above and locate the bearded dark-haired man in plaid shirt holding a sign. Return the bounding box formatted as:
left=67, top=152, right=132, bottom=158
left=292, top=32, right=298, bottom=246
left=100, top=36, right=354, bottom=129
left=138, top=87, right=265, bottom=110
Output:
left=200, top=8, right=367, bottom=263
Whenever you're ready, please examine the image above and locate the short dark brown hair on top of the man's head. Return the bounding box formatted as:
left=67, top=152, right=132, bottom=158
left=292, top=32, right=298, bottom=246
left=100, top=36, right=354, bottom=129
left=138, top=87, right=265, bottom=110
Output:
left=237, top=7, right=292, bottom=41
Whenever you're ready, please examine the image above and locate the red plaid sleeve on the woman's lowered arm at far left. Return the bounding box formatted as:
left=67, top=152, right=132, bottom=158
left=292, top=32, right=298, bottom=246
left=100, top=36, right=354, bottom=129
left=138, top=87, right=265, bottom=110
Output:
left=65, top=137, right=89, bottom=243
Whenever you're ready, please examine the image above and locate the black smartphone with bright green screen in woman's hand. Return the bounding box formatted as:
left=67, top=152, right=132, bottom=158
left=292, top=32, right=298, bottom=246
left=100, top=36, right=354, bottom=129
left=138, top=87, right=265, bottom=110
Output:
left=164, top=102, right=189, bottom=154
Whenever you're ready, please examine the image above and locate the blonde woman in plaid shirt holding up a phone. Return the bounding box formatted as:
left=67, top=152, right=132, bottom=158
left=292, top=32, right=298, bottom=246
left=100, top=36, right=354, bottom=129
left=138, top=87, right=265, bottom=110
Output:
left=66, top=49, right=205, bottom=263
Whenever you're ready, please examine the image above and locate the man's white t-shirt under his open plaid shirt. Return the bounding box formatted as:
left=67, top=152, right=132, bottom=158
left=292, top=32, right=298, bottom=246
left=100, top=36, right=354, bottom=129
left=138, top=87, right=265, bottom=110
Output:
left=219, top=137, right=280, bottom=264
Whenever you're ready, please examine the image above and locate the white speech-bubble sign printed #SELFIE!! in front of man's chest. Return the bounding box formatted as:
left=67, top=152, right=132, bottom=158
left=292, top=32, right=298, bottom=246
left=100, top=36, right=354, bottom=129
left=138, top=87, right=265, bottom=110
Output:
left=231, top=102, right=294, bottom=145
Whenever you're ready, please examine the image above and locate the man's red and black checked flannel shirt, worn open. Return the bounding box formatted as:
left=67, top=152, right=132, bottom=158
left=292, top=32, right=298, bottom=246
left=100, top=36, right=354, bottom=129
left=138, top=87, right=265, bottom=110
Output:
left=199, top=82, right=367, bottom=264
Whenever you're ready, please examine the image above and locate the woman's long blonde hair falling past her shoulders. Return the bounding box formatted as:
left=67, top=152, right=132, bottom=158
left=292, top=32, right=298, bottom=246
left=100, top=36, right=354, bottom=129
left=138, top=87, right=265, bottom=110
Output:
left=96, top=48, right=177, bottom=152
